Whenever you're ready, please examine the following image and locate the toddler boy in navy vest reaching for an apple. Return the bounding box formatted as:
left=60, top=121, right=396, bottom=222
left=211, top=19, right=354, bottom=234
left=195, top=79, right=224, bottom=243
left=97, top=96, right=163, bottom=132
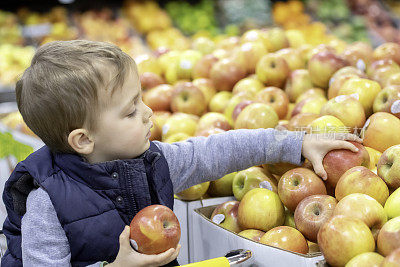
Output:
left=2, top=40, right=360, bottom=266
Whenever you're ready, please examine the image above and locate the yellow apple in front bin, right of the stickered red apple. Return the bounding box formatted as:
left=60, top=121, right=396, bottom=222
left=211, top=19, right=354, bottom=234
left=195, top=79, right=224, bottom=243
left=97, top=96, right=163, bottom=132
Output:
left=238, top=188, right=285, bottom=232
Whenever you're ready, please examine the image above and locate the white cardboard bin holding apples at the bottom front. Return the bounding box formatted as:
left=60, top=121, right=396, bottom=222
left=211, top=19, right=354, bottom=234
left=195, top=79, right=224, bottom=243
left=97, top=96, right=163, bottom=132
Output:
left=189, top=205, right=326, bottom=267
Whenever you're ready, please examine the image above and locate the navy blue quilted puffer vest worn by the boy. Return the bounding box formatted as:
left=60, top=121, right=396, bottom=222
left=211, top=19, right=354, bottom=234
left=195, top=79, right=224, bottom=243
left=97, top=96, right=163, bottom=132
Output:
left=1, top=142, right=177, bottom=267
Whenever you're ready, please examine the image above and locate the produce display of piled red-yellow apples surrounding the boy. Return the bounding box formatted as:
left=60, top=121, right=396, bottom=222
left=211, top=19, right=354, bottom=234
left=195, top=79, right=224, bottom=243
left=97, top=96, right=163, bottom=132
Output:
left=0, top=0, right=400, bottom=266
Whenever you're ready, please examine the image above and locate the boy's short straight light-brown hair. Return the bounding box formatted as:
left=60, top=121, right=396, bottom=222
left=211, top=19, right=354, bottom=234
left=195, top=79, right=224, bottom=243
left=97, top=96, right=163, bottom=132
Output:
left=16, top=40, right=137, bottom=153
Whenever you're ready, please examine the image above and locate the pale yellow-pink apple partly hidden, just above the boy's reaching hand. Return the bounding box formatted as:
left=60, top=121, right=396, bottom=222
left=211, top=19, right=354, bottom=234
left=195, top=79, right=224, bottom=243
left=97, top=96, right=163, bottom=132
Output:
left=321, top=95, right=365, bottom=130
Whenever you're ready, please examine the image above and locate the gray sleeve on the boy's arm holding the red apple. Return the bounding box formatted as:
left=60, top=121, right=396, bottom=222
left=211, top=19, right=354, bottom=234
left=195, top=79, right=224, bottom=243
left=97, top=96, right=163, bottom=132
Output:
left=21, top=188, right=101, bottom=267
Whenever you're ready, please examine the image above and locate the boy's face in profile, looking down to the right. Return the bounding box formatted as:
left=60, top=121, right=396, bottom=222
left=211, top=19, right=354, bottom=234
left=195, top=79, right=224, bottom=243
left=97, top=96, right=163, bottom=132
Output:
left=92, top=71, right=153, bottom=162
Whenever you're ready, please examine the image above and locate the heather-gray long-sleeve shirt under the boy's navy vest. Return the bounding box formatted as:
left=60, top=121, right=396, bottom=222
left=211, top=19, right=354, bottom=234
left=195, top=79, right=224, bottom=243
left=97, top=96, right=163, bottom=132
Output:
left=21, top=129, right=303, bottom=266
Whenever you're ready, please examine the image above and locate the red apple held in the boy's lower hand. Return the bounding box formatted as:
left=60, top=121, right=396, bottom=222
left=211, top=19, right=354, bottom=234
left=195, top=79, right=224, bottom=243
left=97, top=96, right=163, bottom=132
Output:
left=130, top=205, right=181, bottom=255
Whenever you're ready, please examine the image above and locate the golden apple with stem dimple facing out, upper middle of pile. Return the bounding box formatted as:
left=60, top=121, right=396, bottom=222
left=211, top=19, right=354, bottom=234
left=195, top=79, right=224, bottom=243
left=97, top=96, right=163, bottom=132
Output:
left=256, top=54, right=290, bottom=88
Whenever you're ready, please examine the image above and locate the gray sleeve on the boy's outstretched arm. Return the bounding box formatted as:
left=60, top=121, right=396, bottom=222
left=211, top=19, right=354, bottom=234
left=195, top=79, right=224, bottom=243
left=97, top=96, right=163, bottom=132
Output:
left=154, top=129, right=304, bottom=193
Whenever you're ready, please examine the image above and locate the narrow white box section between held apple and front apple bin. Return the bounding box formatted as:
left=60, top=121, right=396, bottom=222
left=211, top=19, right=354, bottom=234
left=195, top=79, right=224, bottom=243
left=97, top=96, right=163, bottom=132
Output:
left=174, top=196, right=235, bottom=265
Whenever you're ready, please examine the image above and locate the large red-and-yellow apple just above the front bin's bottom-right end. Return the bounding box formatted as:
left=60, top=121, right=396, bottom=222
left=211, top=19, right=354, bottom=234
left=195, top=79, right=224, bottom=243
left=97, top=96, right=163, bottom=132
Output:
left=318, top=215, right=375, bottom=266
